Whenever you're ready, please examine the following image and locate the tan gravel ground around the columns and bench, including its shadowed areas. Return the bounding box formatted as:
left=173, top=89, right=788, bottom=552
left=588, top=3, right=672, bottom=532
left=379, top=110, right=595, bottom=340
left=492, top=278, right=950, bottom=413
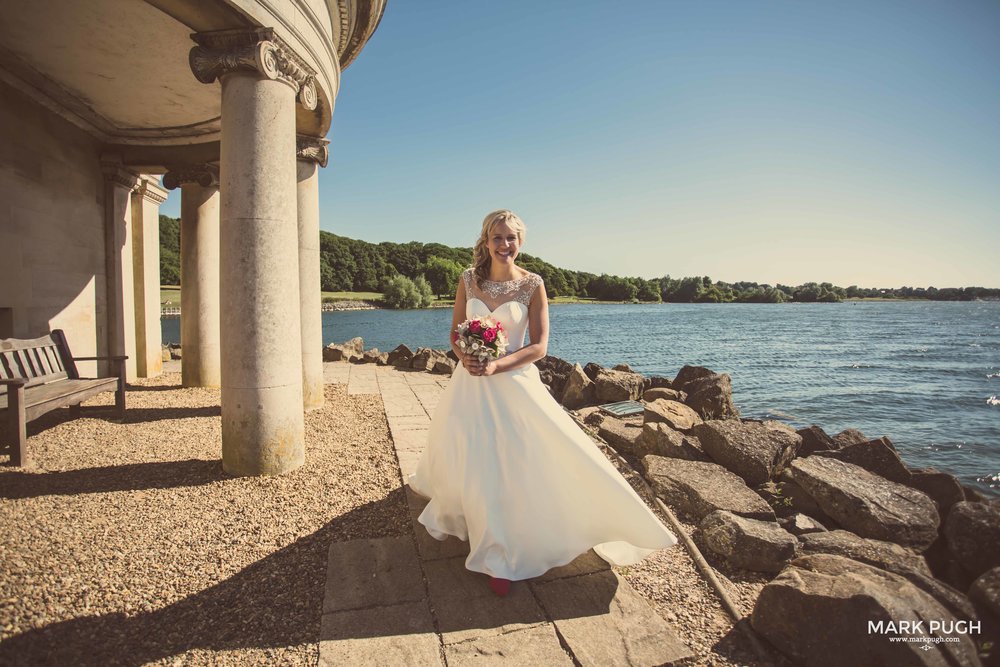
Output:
left=0, top=373, right=410, bottom=665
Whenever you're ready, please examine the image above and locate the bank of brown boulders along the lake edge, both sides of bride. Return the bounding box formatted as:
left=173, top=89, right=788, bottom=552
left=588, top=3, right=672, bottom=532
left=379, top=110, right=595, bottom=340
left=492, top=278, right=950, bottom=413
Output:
left=323, top=338, right=1000, bottom=665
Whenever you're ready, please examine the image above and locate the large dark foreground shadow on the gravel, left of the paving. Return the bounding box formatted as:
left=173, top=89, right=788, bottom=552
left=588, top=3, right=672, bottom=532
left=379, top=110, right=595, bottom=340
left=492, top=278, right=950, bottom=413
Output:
left=0, top=486, right=406, bottom=665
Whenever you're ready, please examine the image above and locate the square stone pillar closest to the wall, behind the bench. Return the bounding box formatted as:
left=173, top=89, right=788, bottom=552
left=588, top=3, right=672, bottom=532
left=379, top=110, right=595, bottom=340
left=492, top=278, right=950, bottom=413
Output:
left=99, top=161, right=139, bottom=380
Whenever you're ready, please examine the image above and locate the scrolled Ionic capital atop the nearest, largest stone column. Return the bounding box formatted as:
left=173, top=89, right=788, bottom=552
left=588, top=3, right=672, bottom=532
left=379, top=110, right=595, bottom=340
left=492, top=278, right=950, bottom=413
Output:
left=188, top=28, right=318, bottom=111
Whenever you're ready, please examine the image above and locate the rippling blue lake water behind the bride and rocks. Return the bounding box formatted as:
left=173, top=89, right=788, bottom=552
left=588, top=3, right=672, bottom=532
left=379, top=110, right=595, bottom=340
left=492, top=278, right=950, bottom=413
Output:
left=163, top=301, right=1000, bottom=495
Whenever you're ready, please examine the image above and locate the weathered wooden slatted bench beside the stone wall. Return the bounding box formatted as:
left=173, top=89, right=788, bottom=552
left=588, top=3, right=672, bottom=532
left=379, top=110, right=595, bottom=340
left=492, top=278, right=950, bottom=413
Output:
left=0, top=329, right=128, bottom=466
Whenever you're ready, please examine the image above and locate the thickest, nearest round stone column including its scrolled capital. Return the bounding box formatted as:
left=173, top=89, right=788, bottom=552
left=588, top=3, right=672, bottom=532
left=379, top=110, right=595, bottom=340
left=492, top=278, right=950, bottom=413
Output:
left=190, top=29, right=316, bottom=475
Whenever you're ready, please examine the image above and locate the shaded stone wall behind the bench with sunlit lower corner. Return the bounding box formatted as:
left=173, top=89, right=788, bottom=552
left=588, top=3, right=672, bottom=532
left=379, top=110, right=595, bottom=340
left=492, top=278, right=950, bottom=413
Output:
left=0, top=83, right=107, bottom=373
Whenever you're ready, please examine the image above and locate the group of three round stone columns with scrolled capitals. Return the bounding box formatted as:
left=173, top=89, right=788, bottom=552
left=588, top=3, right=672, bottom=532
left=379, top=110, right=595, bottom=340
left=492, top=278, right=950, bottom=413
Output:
left=164, top=29, right=327, bottom=475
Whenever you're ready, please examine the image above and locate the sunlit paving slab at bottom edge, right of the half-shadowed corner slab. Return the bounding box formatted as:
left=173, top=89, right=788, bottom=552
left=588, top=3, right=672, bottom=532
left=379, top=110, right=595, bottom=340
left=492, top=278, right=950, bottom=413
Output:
left=444, top=623, right=573, bottom=667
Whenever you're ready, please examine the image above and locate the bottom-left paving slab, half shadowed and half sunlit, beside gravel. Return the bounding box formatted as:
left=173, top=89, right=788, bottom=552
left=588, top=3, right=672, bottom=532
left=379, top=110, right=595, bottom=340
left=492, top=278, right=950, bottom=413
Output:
left=319, top=599, right=444, bottom=667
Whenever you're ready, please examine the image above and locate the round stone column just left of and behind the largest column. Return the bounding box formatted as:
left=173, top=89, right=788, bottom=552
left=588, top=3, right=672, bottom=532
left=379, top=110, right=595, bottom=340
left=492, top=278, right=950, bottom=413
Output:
left=163, top=164, right=222, bottom=387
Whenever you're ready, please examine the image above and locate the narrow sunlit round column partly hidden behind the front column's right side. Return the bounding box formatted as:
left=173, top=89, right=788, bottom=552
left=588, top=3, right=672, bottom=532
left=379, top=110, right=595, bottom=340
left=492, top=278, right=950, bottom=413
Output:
left=296, top=135, right=330, bottom=410
